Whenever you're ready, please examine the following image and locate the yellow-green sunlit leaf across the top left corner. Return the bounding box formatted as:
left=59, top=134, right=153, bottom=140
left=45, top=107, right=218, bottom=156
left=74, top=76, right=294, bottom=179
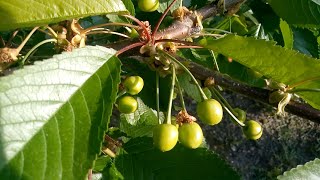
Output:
left=0, top=0, right=126, bottom=31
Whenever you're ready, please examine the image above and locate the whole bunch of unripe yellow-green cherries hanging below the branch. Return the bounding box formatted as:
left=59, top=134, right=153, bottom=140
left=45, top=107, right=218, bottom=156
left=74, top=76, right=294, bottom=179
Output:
left=117, top=76, right=263, bottom=152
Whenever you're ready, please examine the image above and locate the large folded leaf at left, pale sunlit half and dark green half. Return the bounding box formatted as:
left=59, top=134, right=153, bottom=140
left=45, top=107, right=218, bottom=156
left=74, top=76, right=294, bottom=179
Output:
left=0, top=46, right=120, bottom=179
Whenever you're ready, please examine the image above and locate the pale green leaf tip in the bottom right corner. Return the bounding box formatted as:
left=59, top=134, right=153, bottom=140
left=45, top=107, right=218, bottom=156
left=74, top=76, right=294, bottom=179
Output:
left=278, top=158, right=320, bottom=180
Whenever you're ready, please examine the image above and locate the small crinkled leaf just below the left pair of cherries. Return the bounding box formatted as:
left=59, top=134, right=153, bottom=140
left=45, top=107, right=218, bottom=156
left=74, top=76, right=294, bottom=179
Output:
left=120, top=98, right=158, bottom=138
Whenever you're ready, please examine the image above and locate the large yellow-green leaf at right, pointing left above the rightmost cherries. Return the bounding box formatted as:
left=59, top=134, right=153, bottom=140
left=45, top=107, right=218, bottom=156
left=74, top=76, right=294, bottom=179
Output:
left=202, top=35, right=320, bottom=109
